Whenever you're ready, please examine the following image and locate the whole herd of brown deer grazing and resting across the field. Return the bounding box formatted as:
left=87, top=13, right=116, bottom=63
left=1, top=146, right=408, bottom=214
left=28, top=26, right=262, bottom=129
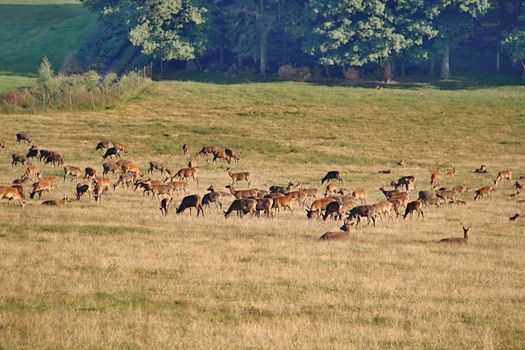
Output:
left=0, top=133, right=523, bottom=243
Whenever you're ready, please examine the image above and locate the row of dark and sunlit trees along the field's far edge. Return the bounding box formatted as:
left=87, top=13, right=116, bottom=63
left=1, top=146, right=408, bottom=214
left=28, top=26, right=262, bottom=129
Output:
left=81, top=0, right=525, bottom=81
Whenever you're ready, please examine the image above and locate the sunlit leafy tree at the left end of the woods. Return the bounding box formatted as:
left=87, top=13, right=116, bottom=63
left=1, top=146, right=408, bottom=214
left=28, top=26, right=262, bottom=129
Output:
left=81, top=0, right=207, bottom=60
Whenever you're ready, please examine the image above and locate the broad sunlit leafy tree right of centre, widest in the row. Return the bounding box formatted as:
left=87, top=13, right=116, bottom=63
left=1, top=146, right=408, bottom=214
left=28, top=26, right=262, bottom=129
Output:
left=304, top=0, right=434, bottom=81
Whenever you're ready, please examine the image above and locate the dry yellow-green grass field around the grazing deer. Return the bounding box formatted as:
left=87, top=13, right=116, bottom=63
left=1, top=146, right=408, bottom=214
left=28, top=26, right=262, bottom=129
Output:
left=0, top=82, right=525, bottom=349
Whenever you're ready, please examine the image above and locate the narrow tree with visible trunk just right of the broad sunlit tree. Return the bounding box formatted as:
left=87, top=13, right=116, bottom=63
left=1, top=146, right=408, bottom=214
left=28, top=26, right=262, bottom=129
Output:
left=430, top=0, right=490, bottom=79
